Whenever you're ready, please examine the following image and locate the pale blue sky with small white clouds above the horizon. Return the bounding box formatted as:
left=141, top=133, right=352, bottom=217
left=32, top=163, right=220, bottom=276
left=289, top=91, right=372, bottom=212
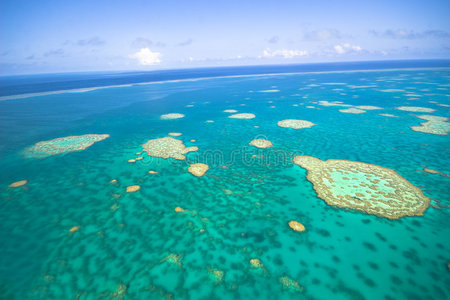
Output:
left=0, top=0, right=450, bottom=75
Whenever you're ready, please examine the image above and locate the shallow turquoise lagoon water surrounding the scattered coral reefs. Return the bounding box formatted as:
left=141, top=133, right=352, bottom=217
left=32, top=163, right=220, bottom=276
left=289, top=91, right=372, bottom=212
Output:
left=0, top=69, right=450, bottom=299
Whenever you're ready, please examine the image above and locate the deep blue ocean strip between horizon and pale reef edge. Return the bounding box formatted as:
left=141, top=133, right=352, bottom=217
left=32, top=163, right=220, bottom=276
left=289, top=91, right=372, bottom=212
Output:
left=0, top=60, right=450, bottom=96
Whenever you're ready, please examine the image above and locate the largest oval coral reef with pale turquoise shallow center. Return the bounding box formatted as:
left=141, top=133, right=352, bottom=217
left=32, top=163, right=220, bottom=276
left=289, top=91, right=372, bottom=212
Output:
left=294, top=156, right=430, bottom=219
